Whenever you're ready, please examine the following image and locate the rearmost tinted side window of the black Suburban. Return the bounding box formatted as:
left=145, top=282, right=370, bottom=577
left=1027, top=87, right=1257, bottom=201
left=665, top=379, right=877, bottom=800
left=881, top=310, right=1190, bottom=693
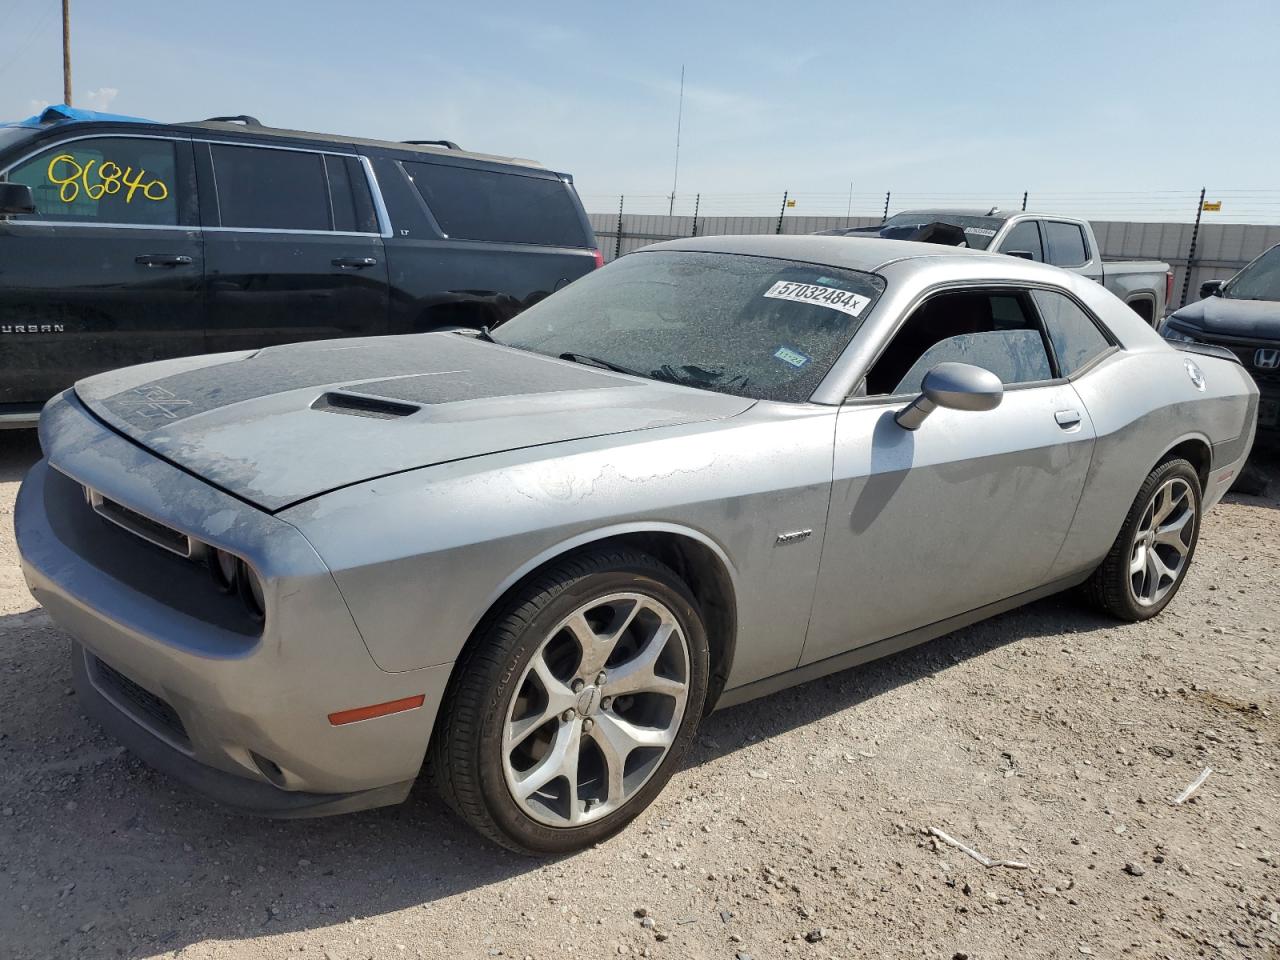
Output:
left=404, top=161, right=586, bottom=247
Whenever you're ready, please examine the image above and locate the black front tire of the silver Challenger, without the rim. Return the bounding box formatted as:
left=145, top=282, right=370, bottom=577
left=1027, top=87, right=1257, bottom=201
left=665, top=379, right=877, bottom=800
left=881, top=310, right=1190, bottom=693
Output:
left=429, top=547, right=710, bottom=856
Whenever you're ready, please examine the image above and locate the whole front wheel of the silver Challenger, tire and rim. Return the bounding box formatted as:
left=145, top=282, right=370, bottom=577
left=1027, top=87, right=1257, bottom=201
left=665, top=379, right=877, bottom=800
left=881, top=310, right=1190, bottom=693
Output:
left=431, top=548, right=709, bottom=855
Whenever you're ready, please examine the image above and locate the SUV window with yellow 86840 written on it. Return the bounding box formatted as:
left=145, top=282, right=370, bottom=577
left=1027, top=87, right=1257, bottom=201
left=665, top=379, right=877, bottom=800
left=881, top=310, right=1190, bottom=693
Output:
left=8, top=137, right=179, bottom=227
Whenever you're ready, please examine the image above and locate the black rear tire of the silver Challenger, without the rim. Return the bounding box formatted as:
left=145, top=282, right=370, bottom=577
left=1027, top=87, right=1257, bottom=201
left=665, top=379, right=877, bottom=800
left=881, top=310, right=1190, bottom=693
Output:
left=1085, top=460, right=1202, bottom=623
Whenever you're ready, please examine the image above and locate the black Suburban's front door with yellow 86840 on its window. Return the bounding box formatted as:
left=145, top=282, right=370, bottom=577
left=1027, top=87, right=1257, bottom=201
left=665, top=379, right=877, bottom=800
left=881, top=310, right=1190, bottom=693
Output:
left=0, top=133, right=205, bottom=404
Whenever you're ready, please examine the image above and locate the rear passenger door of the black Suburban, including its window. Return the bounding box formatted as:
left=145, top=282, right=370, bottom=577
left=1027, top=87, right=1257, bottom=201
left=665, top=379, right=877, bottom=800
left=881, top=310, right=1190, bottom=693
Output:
left=196, top=141, right=388, bottom=352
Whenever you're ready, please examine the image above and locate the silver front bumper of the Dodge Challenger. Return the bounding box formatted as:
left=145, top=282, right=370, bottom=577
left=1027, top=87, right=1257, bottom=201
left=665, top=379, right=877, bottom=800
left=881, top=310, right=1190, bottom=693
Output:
left=14, top=397, right=449, bottom=817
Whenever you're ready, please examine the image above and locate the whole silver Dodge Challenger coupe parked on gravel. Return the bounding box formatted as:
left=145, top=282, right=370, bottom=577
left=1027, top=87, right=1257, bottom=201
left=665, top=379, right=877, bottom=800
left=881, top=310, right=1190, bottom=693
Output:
left=14, top=237, right=1258, bottom=854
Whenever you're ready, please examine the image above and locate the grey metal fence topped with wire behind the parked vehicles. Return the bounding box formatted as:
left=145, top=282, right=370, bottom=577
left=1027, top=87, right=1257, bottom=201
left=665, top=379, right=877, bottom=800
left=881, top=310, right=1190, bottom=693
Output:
left=590, top=212, right=1280, bottom=307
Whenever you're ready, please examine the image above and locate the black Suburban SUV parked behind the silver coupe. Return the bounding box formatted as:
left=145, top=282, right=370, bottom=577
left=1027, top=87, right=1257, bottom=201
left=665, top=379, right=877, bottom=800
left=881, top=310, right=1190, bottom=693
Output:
left=0, top=108, right=602, bottom=426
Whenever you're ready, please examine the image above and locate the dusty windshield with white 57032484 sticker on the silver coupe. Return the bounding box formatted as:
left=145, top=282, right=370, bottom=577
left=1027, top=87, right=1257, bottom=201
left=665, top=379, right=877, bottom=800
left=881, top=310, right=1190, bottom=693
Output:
left=494, top=251, right=884, bottom=402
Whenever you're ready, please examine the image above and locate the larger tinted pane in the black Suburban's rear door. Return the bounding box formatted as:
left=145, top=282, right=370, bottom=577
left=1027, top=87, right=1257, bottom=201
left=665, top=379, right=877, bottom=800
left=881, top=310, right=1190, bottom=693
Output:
left=211, top=143, right=333, bottom=230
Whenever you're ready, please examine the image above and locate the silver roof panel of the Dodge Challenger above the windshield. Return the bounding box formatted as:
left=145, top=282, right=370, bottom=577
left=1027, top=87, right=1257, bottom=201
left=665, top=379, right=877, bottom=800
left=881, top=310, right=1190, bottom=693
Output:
left=636, top=233, right=1013, bottom=273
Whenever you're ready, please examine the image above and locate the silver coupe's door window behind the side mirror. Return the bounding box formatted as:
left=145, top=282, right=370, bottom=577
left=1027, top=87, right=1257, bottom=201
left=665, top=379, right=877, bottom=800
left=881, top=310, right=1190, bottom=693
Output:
left=867, top=291, right=1053, bottom=396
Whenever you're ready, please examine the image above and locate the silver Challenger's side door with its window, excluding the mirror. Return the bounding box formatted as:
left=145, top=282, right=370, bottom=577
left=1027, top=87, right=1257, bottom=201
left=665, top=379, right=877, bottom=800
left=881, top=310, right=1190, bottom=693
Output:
left=801, top=281, right=1093, bottom=664
